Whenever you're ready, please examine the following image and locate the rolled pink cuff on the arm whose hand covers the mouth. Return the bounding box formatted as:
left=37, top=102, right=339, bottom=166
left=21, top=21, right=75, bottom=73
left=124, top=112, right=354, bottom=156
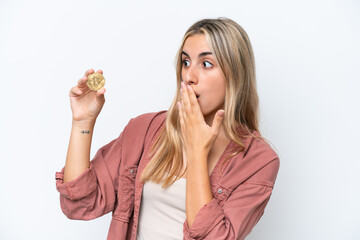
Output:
left=183, top=198, right=225, bottom=239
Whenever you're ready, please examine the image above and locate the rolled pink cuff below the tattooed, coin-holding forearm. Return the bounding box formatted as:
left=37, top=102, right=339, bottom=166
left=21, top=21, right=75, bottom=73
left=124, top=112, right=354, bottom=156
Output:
left=55, top=164, right=97, bottom=200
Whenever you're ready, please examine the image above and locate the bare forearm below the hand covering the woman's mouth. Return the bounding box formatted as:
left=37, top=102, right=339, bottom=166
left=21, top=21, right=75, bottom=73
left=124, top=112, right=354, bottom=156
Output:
left=186, top=153, right=213, bottom=227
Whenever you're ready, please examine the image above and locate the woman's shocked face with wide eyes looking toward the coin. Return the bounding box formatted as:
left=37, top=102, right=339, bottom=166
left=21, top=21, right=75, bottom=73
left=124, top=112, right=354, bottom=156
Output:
left=181, top=34, right=226, bottom=122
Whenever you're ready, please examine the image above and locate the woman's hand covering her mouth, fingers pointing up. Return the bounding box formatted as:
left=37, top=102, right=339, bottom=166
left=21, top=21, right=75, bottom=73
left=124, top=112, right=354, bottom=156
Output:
left=177, top=82, right=225, bottom=162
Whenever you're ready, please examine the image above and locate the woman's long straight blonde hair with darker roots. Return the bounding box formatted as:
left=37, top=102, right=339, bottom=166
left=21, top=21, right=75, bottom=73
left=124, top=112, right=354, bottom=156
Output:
left=141, top=18, right=264, bottom=188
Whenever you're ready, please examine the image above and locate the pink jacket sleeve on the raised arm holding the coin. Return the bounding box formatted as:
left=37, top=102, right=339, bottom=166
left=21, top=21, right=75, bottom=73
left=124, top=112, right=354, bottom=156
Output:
left=56, top=128, right=126, bottom=220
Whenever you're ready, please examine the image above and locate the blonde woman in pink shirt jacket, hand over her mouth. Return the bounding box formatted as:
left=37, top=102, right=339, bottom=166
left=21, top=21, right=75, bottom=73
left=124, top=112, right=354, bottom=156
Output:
left=56, top=18, right=279, bottom=239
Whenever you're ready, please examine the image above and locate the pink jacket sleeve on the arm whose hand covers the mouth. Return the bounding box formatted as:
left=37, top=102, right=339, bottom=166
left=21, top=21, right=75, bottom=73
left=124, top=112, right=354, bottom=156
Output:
left=183, top=158, right=279, bottom=240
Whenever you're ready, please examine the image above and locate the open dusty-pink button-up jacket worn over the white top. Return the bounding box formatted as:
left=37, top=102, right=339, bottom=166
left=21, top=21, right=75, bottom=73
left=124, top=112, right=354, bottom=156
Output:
left=56, top=111, right=279, bottom=240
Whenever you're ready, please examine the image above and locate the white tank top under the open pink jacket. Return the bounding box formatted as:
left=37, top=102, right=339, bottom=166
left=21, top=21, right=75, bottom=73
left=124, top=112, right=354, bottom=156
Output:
left=136, top=178, right=186, bottom=240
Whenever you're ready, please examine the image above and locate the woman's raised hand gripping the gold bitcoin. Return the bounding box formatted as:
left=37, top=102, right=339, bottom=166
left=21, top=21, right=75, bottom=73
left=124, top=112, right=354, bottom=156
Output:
left=69, top=69, right=106, bottom=122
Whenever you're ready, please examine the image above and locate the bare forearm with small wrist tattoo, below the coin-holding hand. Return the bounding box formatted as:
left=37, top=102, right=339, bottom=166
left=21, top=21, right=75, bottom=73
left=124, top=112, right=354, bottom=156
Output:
left=64, top=121, right=95, bottom=182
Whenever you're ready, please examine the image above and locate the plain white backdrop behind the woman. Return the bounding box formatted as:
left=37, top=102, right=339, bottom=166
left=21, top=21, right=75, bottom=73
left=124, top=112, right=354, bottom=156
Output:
left=0, top=0, right=360, bottom=240
